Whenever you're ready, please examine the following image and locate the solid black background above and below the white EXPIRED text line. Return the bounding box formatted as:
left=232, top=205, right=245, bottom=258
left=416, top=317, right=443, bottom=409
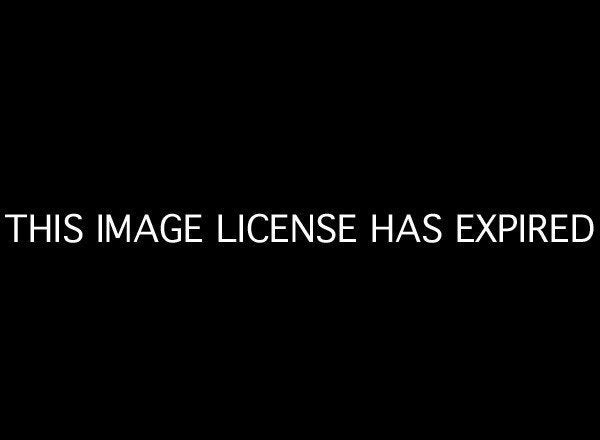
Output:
left=1, top=5, right=598, bottom=433
